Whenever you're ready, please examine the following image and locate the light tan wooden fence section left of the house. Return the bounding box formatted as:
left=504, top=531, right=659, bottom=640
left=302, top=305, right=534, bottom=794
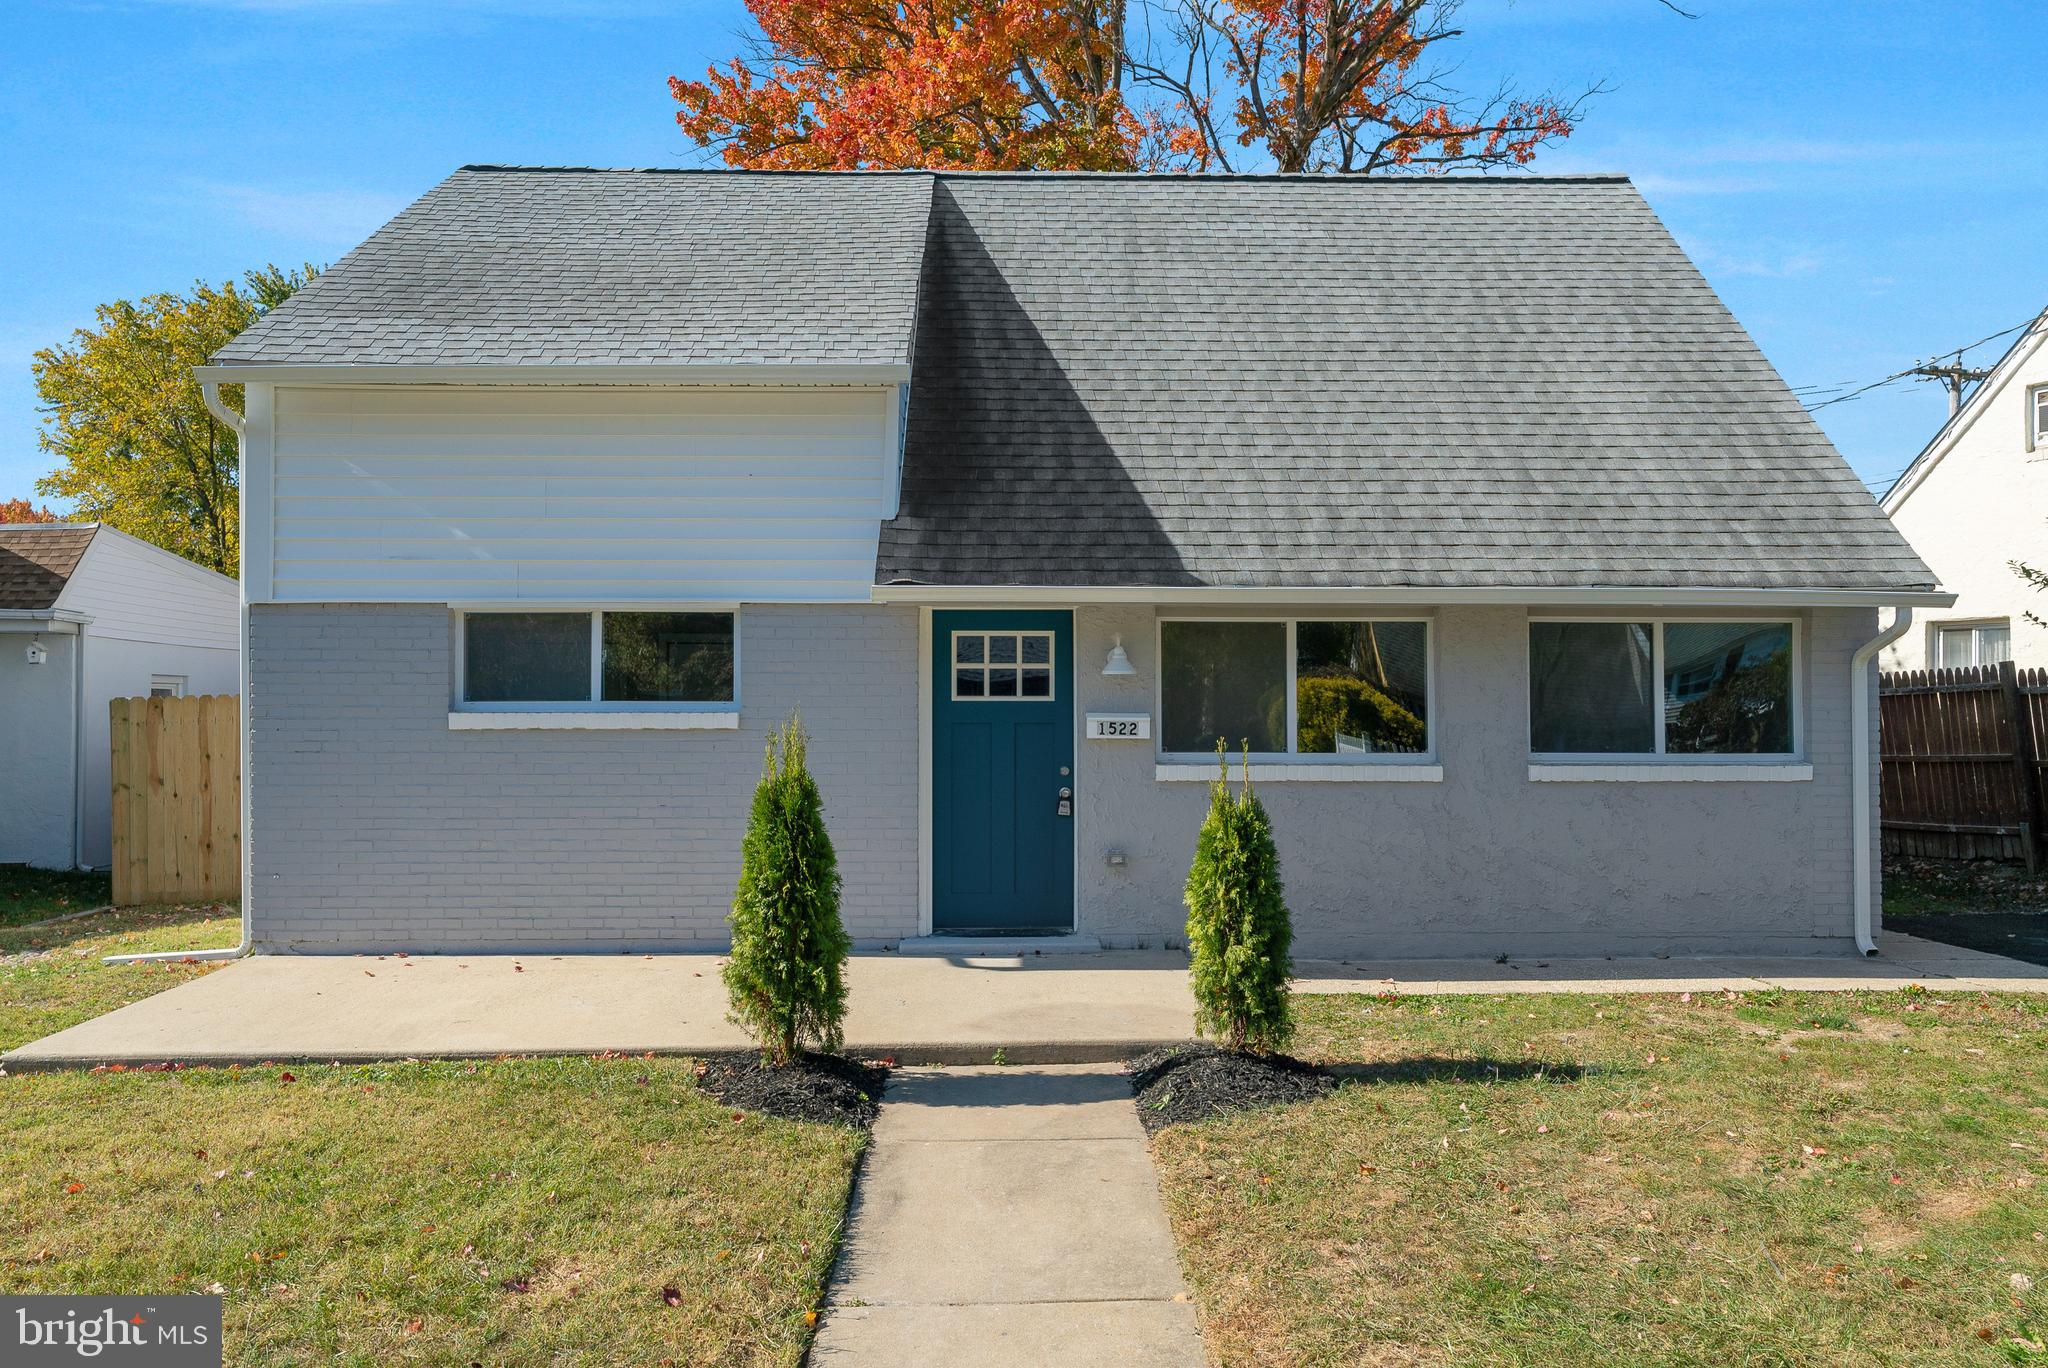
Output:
left=109, top=694, right=242, bottom=903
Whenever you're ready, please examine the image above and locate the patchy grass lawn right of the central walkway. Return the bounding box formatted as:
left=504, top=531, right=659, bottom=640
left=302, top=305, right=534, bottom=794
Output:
left=1155, top=991, right=2048, bottom=1366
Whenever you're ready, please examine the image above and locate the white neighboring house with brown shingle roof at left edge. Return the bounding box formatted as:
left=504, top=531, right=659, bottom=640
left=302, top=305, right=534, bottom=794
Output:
left=0, top=522, right=242, bottom=868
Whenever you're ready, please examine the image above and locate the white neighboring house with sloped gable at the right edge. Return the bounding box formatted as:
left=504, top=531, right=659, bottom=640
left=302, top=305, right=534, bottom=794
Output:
left=1884, top=313, right=2048, bottom=670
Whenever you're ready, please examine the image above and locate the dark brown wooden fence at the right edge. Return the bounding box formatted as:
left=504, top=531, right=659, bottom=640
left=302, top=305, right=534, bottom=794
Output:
left=1878, top=661, right=2048, bottom=870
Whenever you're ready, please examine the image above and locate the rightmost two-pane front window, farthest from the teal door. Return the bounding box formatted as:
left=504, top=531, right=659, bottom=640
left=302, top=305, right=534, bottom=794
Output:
left=1530, top=621, right=1798, bottom=758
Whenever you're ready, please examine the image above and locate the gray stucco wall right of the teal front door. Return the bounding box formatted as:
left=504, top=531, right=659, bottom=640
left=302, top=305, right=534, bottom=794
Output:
left=1075, top=606, right=1876, bottom=958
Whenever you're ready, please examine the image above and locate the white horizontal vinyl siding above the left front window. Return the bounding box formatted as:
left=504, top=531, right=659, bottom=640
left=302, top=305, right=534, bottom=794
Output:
left=252, top=385, right=897, bottom=602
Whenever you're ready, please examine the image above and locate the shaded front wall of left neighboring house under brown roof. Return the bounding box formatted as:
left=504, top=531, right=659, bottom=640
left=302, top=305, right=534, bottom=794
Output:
left=0, top=631, right=78, bottom=868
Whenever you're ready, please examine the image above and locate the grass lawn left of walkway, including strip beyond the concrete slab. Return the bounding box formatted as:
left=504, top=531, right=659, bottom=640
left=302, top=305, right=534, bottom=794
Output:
left=0, top=909, right=864, bottom=1364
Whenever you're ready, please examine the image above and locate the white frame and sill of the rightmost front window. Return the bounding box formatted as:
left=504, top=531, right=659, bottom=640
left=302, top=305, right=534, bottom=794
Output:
left=1522, top=612, right=1812, bottom=782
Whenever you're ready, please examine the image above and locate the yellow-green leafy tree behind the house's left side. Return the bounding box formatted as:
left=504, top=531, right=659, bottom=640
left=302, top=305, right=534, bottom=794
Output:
left=33, top=264, right=319, bottom=575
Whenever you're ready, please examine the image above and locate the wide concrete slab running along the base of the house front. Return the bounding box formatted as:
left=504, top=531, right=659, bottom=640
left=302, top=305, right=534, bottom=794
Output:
left=0, top=936, right=2048, bottom=1071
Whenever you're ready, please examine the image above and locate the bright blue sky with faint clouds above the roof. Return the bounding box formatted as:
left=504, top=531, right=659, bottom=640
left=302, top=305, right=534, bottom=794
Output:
left=0, top=0, right=2048, bottom=500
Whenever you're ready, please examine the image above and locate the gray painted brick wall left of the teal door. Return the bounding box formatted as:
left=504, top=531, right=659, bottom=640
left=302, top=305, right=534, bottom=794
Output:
left=248, top=604, right=918, bottom=950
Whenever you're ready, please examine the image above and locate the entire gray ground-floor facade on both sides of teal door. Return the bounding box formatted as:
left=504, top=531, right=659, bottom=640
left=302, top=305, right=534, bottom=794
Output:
left=250, top=604, right=1876, bottom=956
